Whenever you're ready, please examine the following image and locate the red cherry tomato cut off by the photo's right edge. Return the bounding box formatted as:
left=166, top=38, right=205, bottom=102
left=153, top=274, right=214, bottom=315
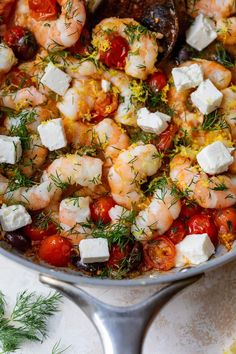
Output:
left=214, top=208, right=236, bottom=234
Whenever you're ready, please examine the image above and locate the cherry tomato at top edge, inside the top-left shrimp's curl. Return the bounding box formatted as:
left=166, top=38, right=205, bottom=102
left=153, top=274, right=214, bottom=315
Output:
left=28, top=0, right=57, bottom=21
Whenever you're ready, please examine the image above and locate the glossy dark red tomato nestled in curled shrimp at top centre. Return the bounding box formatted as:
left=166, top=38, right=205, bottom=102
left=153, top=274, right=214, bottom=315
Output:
left=100, top=35, right=130, bottom=68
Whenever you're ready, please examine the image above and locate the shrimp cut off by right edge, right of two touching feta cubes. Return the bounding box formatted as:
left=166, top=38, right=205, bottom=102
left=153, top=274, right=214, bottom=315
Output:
left=220, top=86, right=236, bottom=139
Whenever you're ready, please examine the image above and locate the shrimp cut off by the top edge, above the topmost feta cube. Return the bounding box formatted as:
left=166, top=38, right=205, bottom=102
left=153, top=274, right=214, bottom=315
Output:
left=187, top=0, right=236, bottom=20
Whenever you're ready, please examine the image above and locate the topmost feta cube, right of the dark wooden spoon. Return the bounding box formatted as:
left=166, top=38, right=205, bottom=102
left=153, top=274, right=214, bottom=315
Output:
left=186, top=14, right=217, bottom=51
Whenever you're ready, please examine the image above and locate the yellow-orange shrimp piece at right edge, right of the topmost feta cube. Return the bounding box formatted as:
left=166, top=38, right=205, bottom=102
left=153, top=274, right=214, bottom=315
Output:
left=216, top=17, right=236, bottom=45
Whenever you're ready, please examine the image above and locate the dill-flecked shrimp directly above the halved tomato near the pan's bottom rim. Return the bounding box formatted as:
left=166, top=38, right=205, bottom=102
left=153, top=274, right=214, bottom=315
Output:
left=131, top=186, right=181, bottom=241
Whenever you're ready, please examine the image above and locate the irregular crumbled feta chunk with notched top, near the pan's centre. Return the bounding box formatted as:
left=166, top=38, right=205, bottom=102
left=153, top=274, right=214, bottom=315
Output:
left=137, top=108, right=171, bottom=134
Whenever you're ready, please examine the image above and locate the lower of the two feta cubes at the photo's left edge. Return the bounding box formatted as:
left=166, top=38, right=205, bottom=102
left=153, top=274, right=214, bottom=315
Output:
left=0, top=205, right=32, bottom=231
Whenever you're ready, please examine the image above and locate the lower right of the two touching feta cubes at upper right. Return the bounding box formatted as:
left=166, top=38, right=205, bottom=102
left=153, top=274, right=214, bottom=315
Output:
left=191, top=79, right=223, bottom=114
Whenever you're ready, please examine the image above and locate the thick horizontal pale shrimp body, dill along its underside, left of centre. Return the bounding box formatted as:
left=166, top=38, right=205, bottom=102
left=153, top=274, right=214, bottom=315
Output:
left=43, top=154, right=102, bottom=189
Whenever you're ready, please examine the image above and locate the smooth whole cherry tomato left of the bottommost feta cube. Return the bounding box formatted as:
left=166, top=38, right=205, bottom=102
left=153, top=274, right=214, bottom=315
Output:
left=38, top=235, right=72, bottom=267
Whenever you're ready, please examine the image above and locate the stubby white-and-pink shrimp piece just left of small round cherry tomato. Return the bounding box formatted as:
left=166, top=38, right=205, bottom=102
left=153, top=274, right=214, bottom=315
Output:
left=59, top=197, right=91, bottom=227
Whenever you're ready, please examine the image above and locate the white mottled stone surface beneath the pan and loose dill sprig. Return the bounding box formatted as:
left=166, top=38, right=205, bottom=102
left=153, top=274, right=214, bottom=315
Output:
left=0, top=257, right=236, bottom=354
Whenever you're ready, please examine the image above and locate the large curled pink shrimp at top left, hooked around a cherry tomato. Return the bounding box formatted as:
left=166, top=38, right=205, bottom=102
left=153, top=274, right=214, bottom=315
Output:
left=15, top=0, right=86, bottom=51
